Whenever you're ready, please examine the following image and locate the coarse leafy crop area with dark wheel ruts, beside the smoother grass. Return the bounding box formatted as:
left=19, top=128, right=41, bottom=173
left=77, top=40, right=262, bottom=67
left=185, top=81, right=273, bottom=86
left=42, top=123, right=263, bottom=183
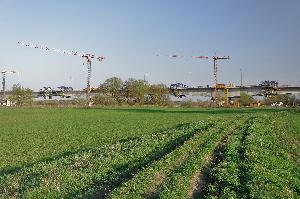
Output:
left=0, top=112, right=300, bottom=198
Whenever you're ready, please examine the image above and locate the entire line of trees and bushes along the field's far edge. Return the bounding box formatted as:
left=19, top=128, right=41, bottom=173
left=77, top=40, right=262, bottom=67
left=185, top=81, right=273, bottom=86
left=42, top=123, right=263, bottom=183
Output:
left=2, top=77, right=300, bottom=107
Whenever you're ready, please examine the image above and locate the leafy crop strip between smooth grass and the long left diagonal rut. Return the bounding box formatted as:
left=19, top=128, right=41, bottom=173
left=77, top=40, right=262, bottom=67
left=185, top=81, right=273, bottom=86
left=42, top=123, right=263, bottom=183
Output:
left=0, top=120, right=218, bottom=198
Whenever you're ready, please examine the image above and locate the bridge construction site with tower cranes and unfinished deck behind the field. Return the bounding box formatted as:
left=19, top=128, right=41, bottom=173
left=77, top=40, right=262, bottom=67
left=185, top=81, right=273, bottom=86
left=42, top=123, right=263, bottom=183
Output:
left=0, top=44, right=300, bottom=107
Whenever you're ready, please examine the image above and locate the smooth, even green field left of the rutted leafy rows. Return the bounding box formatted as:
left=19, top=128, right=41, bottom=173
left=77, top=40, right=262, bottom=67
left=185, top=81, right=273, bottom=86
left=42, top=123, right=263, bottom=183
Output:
left=0, top=109, right=213, bottom=172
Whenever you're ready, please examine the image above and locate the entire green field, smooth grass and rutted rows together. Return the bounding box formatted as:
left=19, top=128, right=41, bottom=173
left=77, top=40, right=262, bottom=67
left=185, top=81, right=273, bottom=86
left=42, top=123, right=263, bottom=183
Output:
left=0, top=108, right=300, bottom=199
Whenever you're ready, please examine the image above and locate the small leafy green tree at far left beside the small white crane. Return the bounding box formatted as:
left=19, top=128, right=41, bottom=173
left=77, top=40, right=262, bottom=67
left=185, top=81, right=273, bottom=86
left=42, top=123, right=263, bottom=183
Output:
left=8, top=84, right=33, bottom=106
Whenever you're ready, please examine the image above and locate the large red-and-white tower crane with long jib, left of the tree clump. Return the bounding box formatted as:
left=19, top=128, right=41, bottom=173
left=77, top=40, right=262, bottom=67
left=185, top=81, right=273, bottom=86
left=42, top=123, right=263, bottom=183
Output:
left=18, top=41, right=105, bottom=106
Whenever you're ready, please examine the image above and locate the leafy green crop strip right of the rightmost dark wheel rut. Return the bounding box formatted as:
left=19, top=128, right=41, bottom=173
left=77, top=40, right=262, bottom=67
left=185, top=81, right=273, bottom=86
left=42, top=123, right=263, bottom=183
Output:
left=245, top=113, right=300, bottom=198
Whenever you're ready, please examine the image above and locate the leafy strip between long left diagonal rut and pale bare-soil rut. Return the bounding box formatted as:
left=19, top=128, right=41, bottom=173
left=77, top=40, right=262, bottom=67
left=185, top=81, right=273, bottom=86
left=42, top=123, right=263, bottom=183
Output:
left=110, top=116, right=246, bottom=198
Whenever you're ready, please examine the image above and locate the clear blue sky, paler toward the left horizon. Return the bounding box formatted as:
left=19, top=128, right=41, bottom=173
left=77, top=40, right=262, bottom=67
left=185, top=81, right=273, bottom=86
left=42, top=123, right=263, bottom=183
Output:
left=0, top=0, right=300, bottom=90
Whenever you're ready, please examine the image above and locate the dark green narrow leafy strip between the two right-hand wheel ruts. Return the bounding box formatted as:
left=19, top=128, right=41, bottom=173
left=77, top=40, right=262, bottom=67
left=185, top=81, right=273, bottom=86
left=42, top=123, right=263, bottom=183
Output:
left=197, top=117, right=253, bottom=198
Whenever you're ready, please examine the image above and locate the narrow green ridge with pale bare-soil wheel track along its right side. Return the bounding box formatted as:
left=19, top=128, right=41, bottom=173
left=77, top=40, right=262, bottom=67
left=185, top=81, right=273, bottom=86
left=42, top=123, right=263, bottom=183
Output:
left=159, top=116, right=245, bottom=198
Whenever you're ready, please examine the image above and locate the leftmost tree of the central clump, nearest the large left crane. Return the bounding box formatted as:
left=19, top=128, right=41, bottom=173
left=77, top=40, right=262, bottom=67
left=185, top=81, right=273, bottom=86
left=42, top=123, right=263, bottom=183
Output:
left=99, top=77, right=123, bottom=101
